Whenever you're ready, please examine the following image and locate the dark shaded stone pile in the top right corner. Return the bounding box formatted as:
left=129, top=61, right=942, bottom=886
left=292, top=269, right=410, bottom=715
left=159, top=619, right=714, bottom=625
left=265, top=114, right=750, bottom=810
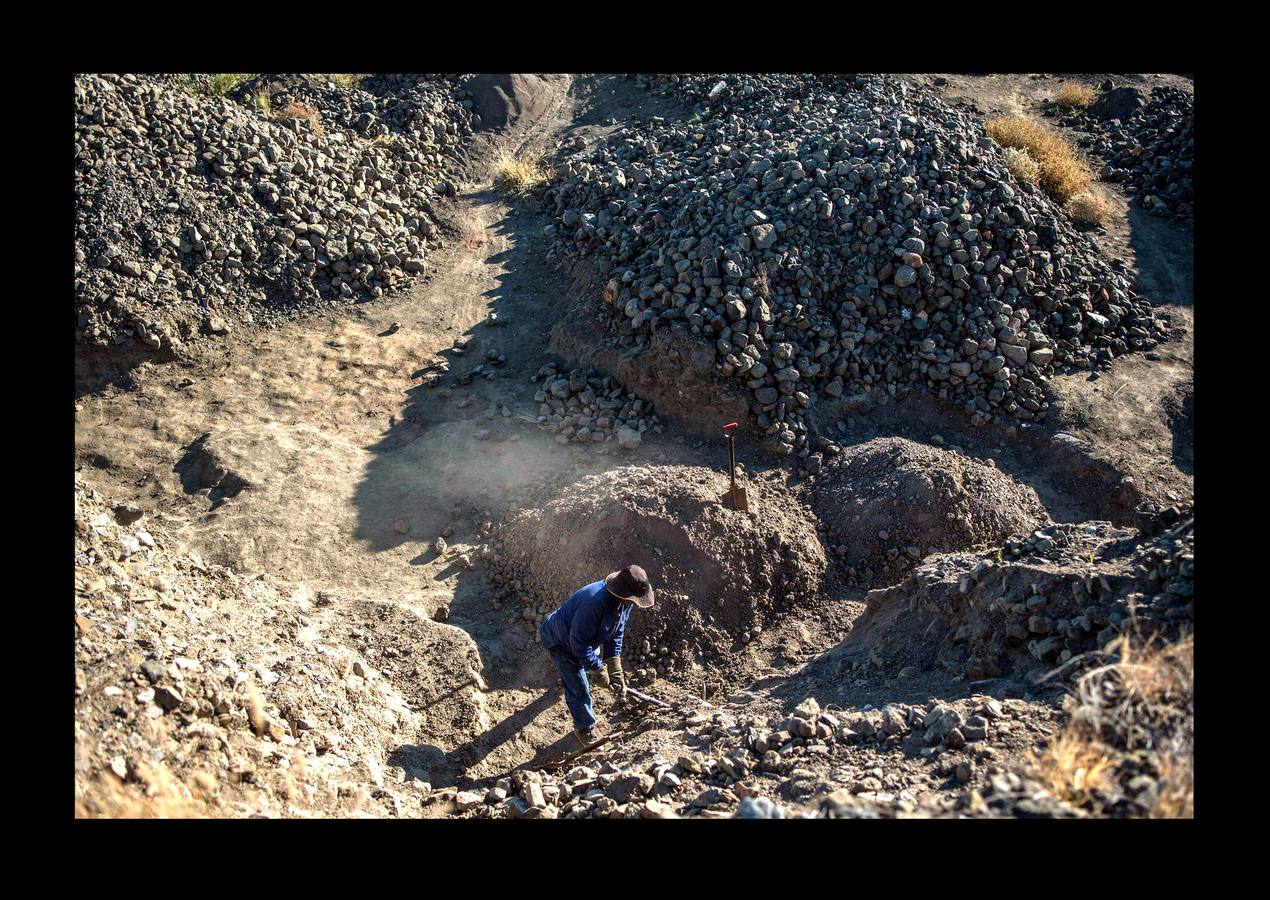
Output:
left=1059, top=85, right=1195, bottom=225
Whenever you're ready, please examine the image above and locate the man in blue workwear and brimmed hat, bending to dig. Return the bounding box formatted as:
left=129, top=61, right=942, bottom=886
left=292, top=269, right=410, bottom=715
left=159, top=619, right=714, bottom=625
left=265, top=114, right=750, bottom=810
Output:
left=538, top=566, right=653, bottom=748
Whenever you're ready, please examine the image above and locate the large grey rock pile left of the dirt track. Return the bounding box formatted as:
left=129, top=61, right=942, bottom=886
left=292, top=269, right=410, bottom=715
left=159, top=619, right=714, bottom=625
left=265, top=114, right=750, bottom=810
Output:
left=75, top=75, right=471, bottom=352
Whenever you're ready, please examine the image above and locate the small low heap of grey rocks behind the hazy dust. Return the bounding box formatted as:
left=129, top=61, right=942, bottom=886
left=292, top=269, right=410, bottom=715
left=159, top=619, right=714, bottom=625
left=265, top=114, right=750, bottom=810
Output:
left=533, top=363, right=662, bottom=449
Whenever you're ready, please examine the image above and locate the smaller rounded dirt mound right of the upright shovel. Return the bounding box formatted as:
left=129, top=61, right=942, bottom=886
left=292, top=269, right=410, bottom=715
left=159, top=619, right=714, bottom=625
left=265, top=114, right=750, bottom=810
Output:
left=814, top=438, right=1049, bottom=583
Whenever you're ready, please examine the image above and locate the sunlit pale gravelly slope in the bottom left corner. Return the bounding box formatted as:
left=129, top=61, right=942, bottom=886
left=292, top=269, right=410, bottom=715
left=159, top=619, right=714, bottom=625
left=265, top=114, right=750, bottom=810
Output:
left=75, top=481, right=480, bottom=817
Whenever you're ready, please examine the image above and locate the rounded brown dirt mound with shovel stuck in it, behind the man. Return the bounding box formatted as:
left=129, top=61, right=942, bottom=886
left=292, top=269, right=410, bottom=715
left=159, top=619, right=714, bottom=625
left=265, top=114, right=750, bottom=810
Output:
left=491, top=466, right=826, bottom=678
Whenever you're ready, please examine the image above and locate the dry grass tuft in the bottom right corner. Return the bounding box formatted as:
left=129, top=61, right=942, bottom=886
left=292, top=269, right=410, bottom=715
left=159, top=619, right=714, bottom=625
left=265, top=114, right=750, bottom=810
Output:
left=1027, top=633, right=1195, bottom=819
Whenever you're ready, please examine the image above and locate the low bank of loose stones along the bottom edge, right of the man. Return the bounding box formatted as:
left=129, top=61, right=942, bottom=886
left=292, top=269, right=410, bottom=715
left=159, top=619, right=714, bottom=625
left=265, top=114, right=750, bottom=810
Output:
left=446, top=692, right=1083, bottom=819
